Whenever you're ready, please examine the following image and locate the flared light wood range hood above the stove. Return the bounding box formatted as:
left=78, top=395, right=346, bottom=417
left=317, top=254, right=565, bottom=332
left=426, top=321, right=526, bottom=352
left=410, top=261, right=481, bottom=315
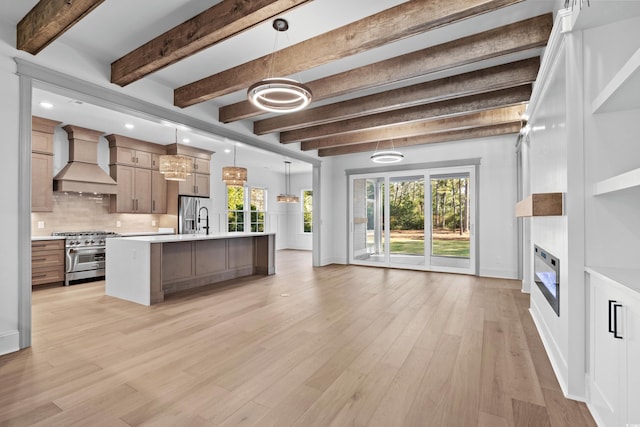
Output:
left=53, top=125, right=116, bottom=194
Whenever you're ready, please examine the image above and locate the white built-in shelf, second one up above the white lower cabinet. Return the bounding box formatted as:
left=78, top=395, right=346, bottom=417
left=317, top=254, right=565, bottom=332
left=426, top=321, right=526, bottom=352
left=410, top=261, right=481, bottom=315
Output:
left=591, top=49, right=640, bottom=114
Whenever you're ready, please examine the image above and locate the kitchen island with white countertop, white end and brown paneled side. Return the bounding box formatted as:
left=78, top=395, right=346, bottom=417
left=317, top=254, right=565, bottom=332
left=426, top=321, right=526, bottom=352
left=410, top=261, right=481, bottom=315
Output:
left=105, top=233, right=276, bottom=305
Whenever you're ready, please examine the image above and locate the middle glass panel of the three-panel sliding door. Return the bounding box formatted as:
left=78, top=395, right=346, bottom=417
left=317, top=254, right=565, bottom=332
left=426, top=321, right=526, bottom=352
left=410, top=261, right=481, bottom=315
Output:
left=389, top=175, right=425, bottom=266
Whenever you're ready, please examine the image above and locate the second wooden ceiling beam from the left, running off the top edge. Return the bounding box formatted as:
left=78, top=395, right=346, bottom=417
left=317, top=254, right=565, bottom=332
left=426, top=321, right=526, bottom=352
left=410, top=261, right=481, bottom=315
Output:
left=111, top=0, right=312, bottom=86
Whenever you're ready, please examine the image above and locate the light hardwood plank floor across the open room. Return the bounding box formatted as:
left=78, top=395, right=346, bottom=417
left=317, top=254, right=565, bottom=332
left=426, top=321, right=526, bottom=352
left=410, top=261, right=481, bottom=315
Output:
left=0, top=251, right=595, bottom=427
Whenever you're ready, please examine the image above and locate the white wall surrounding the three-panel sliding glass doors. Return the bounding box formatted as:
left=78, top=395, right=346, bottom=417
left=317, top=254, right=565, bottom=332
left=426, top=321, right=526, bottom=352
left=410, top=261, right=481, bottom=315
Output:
left=323, top=135, right=518, bottom=279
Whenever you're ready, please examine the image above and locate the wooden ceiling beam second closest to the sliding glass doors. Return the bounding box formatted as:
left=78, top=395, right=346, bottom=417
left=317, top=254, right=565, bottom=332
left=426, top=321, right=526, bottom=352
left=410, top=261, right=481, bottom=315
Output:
left=300, top=104, right=525, bottom=151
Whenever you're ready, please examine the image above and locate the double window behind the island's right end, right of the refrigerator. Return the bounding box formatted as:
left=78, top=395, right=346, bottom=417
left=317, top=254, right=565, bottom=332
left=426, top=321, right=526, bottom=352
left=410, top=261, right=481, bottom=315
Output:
left=227, top=187, right=267, bottom=233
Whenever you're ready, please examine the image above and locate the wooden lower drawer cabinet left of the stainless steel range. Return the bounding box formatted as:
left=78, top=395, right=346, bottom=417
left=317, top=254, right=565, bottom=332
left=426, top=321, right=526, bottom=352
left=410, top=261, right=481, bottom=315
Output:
left=31, top=239, right=65, bottom=286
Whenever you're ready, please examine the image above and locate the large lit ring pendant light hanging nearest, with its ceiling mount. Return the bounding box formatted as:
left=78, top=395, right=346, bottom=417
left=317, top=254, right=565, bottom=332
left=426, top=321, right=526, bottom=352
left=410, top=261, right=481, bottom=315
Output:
left=247, top=18, right=313, bottom=113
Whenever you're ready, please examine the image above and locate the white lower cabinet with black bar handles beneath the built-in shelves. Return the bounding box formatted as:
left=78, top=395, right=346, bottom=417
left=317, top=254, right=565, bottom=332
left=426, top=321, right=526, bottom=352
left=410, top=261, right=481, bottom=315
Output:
left=588, top=270, right=640, bottom=426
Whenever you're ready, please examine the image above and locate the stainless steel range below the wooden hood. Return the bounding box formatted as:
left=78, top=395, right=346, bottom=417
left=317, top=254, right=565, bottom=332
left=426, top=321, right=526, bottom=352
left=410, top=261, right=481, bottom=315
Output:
left=52, top=231, right=118, bottom=286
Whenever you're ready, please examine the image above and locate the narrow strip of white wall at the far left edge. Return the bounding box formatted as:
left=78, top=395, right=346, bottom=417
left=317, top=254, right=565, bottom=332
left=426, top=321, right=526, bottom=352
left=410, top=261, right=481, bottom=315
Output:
left=0, top=18, right=21, bottom=354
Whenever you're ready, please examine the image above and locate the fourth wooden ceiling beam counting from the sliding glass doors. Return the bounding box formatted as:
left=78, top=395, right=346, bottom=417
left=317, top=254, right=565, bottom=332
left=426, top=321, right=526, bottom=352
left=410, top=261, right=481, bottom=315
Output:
left=253, top=57, right=540, bottom=135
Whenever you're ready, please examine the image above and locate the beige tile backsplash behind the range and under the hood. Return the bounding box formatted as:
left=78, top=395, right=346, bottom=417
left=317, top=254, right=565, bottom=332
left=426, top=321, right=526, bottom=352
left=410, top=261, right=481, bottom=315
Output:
left=31, top=192, right=175, bottom=236
